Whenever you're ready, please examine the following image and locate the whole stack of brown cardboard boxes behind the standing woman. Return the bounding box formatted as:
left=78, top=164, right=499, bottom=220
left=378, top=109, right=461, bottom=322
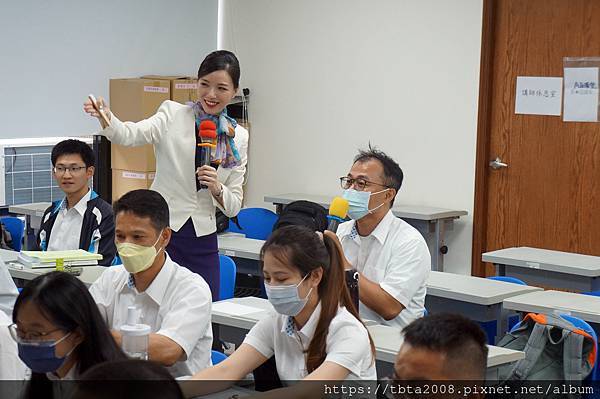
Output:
left=110, top=75, right=197, bottom=201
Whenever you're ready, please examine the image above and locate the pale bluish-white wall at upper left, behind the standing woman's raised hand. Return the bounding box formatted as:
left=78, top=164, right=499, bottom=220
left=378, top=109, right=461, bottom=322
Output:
left=0, top=0, right=218, bottom=139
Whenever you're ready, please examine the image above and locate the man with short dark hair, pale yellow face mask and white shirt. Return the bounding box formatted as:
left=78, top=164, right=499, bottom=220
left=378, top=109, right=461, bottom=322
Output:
left=90, top=190, right=212, bottom=377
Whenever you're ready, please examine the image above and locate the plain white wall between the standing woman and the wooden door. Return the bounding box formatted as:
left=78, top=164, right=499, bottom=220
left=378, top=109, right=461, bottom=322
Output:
left=219, top=0, right=482, bottom=274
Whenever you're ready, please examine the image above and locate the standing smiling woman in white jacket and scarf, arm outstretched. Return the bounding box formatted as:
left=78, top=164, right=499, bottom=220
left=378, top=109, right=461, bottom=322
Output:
left=84, top=50, right=248, bottom=300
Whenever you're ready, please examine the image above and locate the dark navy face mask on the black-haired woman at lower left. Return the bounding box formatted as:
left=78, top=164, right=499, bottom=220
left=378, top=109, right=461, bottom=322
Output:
left=17, top=333, right=75, bottom=373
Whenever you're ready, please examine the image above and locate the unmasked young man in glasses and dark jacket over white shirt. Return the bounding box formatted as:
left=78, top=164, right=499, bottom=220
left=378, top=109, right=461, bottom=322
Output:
left=38, top=140, right=117, bottom=266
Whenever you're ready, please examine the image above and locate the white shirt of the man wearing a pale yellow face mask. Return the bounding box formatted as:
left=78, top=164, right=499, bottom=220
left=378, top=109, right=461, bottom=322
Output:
left=90, top=255, right=212, bottom=377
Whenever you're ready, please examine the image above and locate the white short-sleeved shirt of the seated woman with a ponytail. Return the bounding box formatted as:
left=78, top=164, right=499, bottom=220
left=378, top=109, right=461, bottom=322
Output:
left=244, top=303, right=377, bottom=382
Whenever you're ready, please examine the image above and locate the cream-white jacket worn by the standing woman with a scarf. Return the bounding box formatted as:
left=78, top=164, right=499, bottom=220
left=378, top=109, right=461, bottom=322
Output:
left=98, top=100, right=248, bottom=237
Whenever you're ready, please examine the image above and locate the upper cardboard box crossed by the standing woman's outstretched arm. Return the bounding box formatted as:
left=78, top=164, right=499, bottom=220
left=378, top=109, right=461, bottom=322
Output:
left=109, top=78, right=171, bottom=172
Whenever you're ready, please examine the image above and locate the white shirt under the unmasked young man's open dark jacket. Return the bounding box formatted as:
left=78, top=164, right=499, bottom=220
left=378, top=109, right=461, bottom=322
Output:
left=48, top=190, right=92, bottom=251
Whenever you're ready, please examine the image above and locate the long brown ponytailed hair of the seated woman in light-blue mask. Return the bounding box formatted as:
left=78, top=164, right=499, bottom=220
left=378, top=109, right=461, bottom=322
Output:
left=260, top=226, right=375, bottom=373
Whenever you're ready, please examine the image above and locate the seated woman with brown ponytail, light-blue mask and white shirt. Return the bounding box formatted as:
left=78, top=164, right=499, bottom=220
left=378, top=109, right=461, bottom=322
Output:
left=183, top=226, right=376, bottom=397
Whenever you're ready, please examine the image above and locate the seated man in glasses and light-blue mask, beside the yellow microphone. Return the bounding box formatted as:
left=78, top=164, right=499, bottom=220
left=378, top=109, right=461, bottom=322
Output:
left=337, top=147, right=431, bottom=328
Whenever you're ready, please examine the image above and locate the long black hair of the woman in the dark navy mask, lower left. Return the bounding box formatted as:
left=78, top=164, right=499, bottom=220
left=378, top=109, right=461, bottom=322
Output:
left=13, top=272, right=127, bottom=397
